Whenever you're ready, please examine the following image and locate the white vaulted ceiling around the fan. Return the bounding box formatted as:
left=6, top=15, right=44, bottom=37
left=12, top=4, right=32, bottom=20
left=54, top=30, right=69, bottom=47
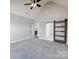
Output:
left=10, top=0, right=68, bottom=19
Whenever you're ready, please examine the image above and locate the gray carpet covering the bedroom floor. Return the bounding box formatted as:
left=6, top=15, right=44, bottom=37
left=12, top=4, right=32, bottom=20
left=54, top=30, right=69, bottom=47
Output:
left=10, top=39, right=68, bottom=59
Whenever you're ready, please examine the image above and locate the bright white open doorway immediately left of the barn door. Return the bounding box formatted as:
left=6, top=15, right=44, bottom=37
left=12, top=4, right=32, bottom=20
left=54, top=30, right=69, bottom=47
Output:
left=46, top=23, right=54, bottom=41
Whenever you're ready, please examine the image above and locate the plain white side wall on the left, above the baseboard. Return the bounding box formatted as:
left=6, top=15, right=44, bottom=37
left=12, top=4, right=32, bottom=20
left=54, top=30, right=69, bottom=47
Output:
left=10, top=14, right=33, bottom=43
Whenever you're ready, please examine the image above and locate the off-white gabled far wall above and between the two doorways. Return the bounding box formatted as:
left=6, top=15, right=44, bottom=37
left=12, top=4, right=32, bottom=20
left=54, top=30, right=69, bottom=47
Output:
left=36, top=2, right=68, bottom=39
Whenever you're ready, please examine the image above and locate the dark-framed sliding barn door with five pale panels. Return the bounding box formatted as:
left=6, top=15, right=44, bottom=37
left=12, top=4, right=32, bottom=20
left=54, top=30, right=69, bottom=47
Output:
left=54, top=19, right=67, bottom=43
